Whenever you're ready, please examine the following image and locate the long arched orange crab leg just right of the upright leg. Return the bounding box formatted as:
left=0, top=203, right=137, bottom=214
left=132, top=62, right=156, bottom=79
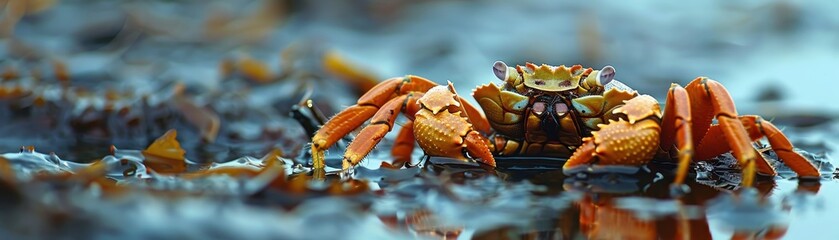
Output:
left=685, top=77, right=757, bottom=186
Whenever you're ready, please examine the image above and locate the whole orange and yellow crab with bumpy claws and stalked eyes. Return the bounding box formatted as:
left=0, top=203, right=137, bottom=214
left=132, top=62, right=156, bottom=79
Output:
left=312, top=61, right=820, bottom=186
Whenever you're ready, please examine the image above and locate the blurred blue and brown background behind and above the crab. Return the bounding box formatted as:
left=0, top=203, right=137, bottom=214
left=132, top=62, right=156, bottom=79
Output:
left=0, top=0, right=839, bottom=160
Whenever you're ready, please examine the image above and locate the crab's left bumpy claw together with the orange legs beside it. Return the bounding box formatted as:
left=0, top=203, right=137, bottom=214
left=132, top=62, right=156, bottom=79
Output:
left=312, top=76, right=495, bottom=169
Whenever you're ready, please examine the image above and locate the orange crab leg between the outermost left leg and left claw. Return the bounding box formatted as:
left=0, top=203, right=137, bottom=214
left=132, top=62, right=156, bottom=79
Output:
left=343, top=93, right=418, bottom=169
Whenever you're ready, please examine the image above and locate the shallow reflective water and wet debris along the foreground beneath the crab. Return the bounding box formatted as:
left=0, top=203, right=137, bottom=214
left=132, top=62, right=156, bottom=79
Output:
left=0, top=143, right=839, bottom=239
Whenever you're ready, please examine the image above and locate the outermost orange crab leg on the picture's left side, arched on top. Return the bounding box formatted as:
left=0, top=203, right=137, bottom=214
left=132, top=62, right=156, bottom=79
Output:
left=312, top=75, right=437, bottom=168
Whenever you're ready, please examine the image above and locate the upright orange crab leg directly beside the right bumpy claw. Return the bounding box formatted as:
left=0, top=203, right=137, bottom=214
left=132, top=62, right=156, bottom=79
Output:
left=660, top=84, right=693, bottom=186
